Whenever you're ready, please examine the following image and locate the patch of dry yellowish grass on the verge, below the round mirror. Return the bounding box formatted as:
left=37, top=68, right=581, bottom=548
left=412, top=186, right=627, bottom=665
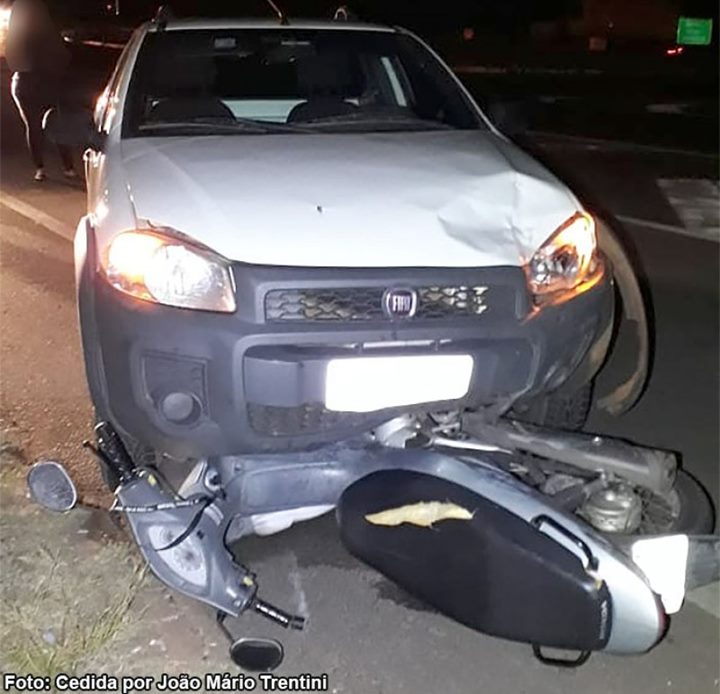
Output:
left=0, top=452, right=147, bottom=677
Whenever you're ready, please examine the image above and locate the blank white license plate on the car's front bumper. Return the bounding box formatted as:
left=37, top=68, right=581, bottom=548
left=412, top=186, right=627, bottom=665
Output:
left=325, top=354, right=473, bottom=412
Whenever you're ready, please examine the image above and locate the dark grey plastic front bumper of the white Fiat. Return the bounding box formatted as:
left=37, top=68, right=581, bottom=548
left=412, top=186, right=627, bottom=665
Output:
left=78, top=224, right=613, bottom=458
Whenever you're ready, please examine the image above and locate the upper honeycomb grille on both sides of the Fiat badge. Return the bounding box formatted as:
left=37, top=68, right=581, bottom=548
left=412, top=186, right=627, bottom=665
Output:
left=265, top=286, right=488, bottom=322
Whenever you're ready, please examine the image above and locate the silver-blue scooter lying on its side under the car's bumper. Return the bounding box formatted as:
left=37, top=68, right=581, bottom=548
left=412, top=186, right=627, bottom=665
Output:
left=29, top=413, right=720, bottom=669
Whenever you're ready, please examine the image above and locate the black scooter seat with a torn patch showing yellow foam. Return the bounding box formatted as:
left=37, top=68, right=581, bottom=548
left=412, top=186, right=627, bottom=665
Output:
left=338, top=470, right=612, bottom=651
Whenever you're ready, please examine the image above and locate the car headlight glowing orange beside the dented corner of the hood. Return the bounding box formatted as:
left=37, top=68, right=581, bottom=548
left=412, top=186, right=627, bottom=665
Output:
left=525, top=212, right=598, bottom=301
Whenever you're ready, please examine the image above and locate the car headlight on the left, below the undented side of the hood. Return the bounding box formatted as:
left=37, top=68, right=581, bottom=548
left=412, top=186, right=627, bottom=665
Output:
left=102, top=231, right=235, bottom=313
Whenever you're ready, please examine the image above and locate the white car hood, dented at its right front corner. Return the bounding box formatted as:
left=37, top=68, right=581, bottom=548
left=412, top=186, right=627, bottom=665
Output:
left=123, top=131, right=579, bottom=267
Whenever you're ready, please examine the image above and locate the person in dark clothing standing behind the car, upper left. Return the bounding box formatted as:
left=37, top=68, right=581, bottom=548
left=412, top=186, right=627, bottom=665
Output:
left=5, top=0, right=77, bottom=182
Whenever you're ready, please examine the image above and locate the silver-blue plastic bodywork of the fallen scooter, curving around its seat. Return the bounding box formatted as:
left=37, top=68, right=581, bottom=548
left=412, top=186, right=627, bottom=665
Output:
left=120, top=445, right=664, bottom=653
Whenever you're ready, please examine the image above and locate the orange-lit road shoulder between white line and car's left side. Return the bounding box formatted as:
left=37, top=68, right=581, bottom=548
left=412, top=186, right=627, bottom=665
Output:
left=0, top=207, right=110, bottom=508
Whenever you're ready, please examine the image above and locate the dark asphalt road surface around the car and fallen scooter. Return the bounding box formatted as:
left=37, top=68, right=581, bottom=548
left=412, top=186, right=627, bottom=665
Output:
left=0, top=53, right=720, bottom=694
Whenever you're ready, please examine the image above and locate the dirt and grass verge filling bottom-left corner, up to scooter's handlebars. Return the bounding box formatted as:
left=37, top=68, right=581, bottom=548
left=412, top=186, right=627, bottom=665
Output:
left=0, top=452, right=230, bottom=692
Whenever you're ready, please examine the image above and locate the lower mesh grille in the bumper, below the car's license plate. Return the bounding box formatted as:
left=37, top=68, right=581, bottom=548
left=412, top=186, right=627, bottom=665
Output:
left=248, top=403, right=368, bottom=436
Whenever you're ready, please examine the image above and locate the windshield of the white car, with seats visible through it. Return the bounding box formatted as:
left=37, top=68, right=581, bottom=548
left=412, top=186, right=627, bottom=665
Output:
left=123, top=29, right=484, bottom=137
